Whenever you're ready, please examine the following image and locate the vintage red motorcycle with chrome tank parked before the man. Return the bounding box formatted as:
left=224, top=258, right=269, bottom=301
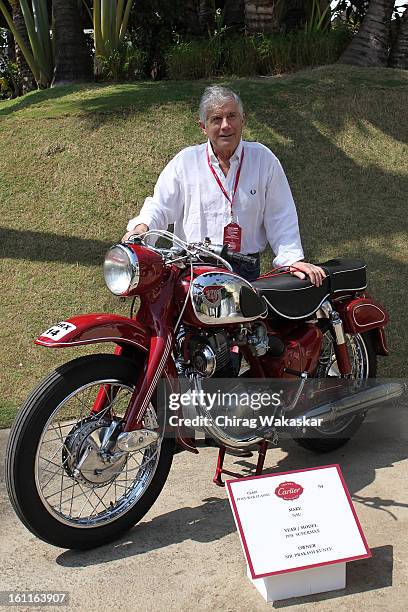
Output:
left=6, top=232, right=403, bottom=549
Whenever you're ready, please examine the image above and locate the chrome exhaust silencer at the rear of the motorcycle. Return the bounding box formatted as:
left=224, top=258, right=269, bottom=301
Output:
left=301, top=382, right=408, bottom=423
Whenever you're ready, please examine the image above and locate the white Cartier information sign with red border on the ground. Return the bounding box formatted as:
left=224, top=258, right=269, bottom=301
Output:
left=227, top=465, right=371, bottom=596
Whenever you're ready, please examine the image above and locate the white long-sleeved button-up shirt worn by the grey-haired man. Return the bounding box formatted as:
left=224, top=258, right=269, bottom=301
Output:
left=127, top=140, right=303, bottom=266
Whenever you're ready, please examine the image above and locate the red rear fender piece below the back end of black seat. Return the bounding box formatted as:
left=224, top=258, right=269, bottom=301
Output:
left=335, top=294, right=389, bottom=355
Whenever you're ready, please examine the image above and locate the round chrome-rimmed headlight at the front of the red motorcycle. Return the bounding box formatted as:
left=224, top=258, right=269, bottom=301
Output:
left=103, top=244, right=140, bottom=295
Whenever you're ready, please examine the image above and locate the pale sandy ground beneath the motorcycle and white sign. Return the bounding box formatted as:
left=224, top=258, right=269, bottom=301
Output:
left=0, top=406, right=408, bottom=612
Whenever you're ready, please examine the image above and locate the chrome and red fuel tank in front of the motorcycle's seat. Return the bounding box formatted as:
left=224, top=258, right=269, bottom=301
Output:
left=176, top=266, right=267, bottom=327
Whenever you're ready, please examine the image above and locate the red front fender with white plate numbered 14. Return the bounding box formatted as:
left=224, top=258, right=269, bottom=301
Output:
left=35, top=313, right=150, bottom=351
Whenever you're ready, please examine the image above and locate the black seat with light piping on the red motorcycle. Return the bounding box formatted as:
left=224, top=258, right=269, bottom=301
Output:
left=251, top=259, right=367, bottom=319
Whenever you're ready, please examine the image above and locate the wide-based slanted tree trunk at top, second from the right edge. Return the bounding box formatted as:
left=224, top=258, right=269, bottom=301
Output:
left=339, top=0, right=395, bottom=67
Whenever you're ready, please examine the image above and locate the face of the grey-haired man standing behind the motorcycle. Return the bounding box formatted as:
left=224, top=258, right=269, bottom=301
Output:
left=200, top=100, right=244, bottom=156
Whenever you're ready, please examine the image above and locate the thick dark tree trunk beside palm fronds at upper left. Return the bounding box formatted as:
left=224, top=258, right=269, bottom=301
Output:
left=51, top=0, right=92, bottom=87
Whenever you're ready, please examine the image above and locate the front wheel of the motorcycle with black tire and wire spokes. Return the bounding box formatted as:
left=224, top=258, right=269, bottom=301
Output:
left=6, top=355, right=174, bottom=550
